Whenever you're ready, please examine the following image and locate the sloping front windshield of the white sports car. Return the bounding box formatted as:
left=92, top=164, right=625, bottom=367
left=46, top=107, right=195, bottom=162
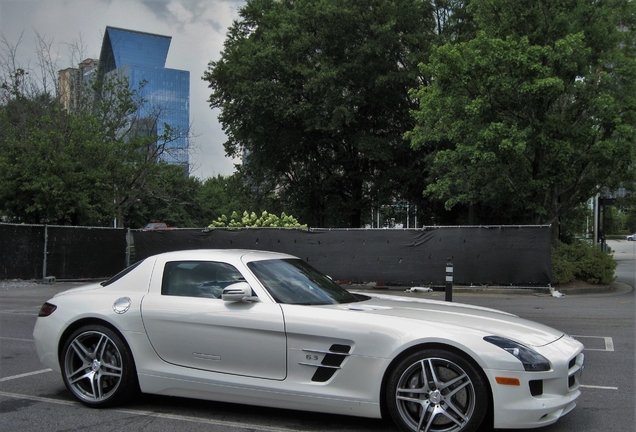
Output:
left=247, top=259, right=359, bottom=305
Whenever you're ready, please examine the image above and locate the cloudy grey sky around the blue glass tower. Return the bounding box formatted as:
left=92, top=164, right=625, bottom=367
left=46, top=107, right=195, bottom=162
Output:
left=0, top=0, right=245, bottom=179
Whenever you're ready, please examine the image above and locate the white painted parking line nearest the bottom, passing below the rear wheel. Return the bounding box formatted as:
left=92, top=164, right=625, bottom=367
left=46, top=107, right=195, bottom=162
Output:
left=0, top=391, right=306, bottom=432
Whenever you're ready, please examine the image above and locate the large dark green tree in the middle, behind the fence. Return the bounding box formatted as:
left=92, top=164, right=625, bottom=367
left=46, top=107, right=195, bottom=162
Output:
left=203, top=0, right=438, bottom=227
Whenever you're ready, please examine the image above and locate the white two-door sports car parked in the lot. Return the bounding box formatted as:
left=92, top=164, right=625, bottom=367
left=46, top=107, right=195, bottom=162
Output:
left=34, top=250, right=583, bottom=432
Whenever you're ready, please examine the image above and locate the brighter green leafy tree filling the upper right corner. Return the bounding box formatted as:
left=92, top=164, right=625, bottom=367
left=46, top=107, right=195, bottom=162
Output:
left=408, top=0, right=636, bottom=242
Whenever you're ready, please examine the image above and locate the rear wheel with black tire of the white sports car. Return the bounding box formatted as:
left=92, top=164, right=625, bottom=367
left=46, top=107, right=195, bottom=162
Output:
left=60, top=325, right=139, bottom=408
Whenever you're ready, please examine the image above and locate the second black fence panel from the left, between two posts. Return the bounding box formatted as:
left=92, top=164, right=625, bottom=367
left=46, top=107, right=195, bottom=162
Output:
left=46, top=226, right=127, bottom=279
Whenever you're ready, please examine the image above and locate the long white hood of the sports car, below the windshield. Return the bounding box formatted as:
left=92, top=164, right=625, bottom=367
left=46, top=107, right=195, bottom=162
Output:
left=340, top=293, right=563, bottom=347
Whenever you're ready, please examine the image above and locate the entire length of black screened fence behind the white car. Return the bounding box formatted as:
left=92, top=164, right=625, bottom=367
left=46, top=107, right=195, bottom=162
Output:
left=0, top=224, right=551, bottom=286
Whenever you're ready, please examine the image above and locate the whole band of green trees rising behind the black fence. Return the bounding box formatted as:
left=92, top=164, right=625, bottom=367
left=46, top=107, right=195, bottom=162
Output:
left=0, top=0, right=636, bottom=233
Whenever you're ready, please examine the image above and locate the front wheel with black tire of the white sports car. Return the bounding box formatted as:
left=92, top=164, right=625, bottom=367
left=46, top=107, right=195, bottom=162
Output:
left=386, top=349, right=489, bottom=432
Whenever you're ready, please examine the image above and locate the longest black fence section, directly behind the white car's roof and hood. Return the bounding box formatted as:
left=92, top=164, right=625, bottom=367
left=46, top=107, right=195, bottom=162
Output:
left=133, top=226, right=552, bottom=286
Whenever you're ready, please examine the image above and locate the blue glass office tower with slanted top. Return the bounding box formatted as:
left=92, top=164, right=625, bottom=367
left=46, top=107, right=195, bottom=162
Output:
left=99, top=27, right=190, bottom=173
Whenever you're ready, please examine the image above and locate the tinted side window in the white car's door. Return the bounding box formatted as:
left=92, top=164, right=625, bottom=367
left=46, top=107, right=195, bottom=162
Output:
left=161, top=261, right=245, bottom=298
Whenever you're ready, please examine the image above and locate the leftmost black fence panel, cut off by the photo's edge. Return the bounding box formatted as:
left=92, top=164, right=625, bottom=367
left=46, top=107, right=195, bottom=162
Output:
left=0, top=224, right=44, bottom=279
